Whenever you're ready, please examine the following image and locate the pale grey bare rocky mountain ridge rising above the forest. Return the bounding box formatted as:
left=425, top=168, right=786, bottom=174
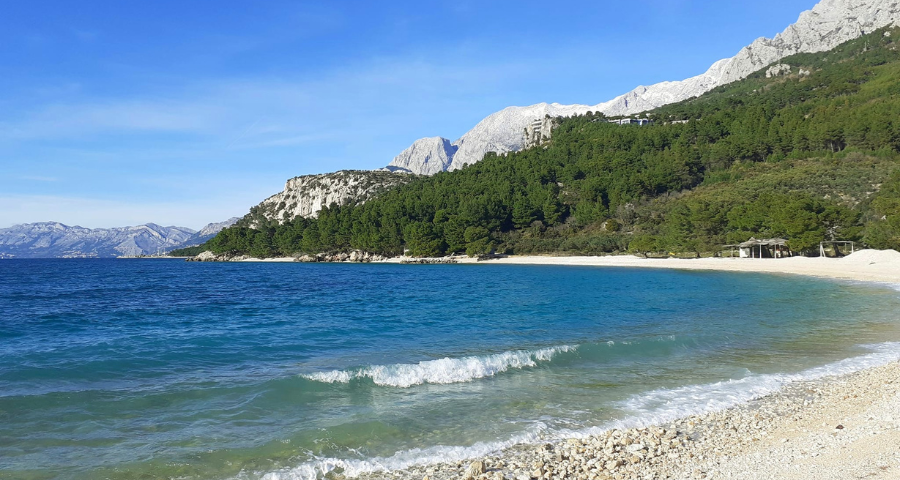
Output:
left=388, top=0, right=900, bottom=175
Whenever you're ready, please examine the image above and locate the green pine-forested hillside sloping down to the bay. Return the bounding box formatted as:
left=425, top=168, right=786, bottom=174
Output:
left=186, top=29, right=900, bottom=256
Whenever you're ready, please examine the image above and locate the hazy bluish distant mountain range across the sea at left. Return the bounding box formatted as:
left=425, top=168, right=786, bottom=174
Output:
left=0, top=217, right=238, bottom=258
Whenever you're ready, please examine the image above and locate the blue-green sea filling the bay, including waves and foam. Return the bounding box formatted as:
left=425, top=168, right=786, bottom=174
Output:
left=0, top=260, right=900, bottom=480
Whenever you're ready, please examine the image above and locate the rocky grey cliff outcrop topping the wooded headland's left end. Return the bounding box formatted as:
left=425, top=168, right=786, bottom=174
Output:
left=241, top=170, right=415, bottom=227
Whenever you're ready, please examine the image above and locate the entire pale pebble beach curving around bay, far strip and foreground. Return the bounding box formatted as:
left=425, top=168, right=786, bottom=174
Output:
left=183, top=250, right=900, bottom=480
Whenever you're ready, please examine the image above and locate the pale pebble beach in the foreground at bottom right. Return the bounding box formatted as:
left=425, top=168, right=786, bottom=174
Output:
left=361, top=363, right=900, bottom=480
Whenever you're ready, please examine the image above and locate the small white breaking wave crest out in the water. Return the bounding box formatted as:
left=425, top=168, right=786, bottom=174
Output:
left=303, top=345, right=577, bottom=388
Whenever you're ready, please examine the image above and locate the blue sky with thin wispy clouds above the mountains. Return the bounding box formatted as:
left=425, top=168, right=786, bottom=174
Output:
left=0, top=0, right=816, bottom=229
